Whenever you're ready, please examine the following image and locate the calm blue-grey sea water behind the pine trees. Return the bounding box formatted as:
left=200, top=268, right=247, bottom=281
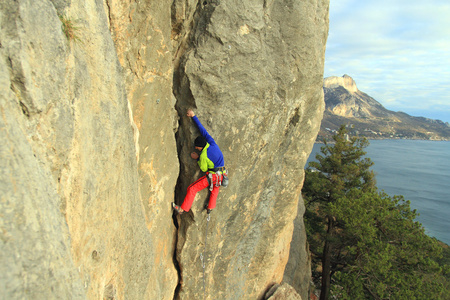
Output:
left=308, top=140, right=450, bottom=245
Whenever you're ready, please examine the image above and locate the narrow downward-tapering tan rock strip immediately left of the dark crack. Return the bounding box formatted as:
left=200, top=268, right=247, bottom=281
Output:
left=107, top=0, right=179, bottom=299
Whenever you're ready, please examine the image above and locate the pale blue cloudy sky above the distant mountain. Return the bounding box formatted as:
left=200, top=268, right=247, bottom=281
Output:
left=324, top=0, right=450, bottom=122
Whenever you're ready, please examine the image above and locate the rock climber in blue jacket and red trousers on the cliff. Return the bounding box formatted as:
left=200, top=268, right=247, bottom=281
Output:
left=172, top=109, right=225, bottom=214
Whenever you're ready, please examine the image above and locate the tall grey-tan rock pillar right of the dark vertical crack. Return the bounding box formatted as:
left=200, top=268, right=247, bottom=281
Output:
left=175, top=1, right=328, bottom=299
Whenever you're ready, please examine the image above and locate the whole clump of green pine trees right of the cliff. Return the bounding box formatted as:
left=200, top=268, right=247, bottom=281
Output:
left=303, top=126, right=449, bottom=299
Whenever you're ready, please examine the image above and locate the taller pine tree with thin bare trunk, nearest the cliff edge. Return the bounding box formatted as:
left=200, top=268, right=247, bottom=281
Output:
left=303, top=126, right=375, bottom=300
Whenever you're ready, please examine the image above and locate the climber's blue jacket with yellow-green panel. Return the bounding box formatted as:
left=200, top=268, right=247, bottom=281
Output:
left=192, top=116, right=225, bottom=173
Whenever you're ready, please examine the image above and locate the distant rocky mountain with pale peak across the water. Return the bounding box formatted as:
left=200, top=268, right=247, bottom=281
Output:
left=317, top=75, right=450, bottom=140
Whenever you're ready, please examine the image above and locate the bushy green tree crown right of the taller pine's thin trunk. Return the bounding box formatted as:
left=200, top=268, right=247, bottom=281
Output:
left=334, top=191, right=442, bottom=299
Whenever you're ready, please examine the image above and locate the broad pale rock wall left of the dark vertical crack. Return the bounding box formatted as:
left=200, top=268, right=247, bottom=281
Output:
left=0, top=0, right=178, bottom=299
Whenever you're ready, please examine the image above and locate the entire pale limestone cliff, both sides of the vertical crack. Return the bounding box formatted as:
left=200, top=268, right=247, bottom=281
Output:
left=0, top=0, right=328, bottom=299
